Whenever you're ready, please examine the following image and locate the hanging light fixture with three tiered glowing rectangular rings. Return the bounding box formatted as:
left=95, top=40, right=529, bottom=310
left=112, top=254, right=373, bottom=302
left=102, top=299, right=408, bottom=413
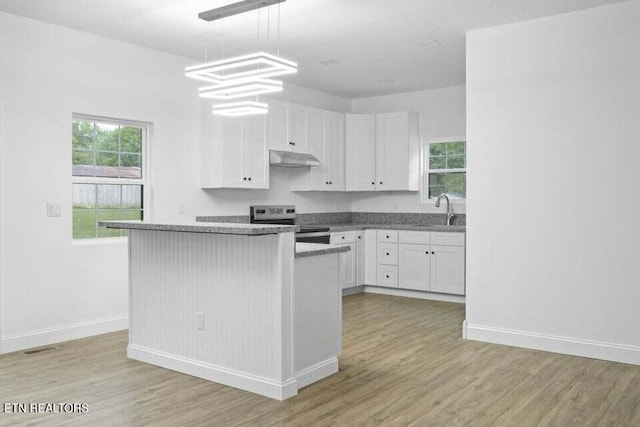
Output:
left=185, top=0, right=298, bottom=117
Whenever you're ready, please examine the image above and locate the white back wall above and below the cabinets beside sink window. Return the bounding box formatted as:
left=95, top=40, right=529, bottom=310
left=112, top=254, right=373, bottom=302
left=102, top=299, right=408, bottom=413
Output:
left=351, top=86, right=466, bottom=213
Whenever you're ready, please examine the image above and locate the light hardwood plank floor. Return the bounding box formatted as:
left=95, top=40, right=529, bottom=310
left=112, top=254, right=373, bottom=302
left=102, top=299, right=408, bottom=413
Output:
left=0, top=294, right=640, bottom=427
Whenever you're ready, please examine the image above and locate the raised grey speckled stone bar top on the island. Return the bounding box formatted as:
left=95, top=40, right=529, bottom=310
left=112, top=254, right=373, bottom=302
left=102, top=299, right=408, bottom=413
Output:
left=98, top=221, right=299, bottom=236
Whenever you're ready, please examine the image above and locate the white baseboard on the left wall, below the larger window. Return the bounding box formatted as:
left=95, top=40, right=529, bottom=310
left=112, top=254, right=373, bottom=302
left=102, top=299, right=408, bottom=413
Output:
left=0, top=314, right=129, bottom=354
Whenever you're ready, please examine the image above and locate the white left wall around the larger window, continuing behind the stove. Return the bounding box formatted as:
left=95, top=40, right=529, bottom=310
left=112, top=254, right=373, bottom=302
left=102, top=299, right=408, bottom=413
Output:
left=0, top=13, right=350, bottom=352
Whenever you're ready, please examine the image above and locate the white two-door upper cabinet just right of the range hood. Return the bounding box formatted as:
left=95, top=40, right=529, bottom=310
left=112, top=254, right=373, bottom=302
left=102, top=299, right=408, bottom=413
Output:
left=291, top=108, right=344, bottom=191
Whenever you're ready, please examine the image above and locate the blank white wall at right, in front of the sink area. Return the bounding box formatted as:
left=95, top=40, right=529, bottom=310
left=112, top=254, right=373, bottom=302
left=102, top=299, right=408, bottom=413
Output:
left=467, top=2, right=640, bottom=364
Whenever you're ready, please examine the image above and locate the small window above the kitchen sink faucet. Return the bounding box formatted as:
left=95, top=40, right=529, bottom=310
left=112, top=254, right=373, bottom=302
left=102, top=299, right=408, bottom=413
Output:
left=423, top=138, right=467, bottom=199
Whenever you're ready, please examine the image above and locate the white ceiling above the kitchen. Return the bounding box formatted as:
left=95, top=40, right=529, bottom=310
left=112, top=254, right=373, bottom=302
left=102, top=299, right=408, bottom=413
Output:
left=0, top=0, right=625, bottom=98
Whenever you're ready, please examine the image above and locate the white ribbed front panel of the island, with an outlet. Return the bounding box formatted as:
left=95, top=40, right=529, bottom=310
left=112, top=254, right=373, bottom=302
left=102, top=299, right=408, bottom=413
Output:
left=128, top=230, right=297, bottom=399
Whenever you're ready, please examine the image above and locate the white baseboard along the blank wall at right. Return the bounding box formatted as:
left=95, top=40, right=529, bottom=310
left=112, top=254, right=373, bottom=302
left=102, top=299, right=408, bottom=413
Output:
left=466, top=324, right=640, bottom=365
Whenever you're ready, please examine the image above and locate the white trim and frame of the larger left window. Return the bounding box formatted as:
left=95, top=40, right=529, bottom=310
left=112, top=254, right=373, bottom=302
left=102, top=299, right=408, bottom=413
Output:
left=71, top=113, right=153, bottom=241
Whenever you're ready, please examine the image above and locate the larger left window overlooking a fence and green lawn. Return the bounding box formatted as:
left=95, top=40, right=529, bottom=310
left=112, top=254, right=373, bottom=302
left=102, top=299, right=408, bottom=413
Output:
left=71, top=115, right=148, bottom=239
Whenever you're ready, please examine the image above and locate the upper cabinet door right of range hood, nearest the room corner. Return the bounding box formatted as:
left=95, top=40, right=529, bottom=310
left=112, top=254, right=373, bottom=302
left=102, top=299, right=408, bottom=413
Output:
left=325, top=112, right=344, bottom=191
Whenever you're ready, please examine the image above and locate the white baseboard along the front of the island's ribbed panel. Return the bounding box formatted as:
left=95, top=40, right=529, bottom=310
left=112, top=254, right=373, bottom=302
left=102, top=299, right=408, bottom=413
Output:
left=127, top=344, right=298, bottom=400
